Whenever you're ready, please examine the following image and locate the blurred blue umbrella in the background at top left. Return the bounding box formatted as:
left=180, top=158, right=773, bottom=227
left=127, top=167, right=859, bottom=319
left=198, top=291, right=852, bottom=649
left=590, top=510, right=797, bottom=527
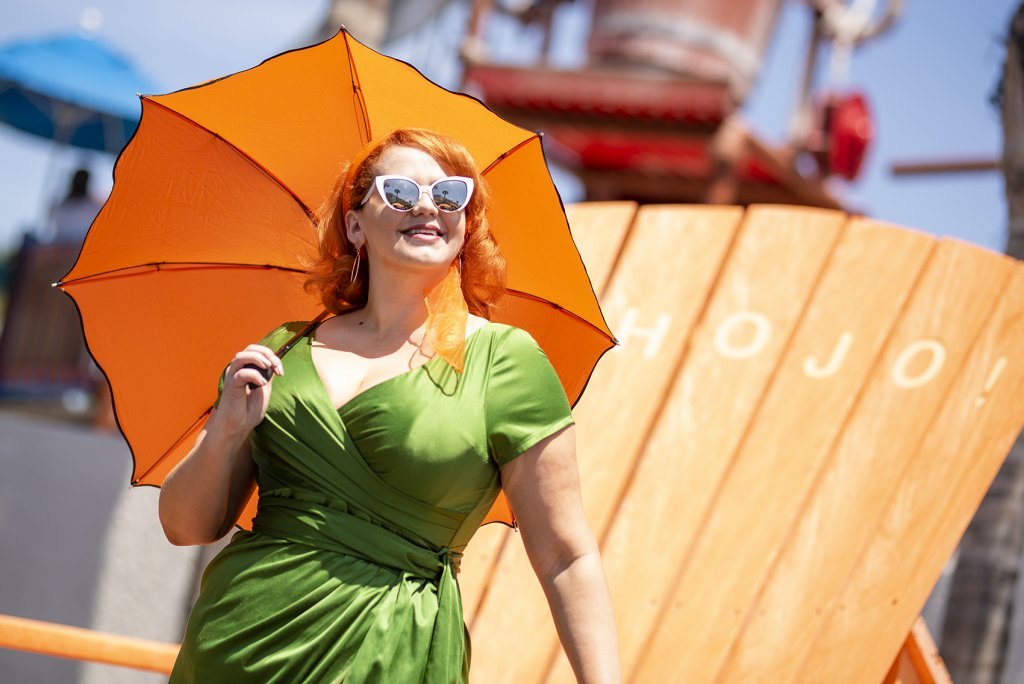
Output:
left=0, top=35, right=156, bottom=154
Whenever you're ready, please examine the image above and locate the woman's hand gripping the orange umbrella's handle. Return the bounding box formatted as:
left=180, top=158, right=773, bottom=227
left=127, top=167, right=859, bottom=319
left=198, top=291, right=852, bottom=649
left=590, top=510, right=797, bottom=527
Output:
left=211, top=344, right=285, bottom=434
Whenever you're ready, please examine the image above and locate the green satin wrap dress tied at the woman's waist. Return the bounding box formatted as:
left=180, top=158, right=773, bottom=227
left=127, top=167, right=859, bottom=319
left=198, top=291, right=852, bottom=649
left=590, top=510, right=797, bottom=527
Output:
left=170, top=323, right=572, bottom=684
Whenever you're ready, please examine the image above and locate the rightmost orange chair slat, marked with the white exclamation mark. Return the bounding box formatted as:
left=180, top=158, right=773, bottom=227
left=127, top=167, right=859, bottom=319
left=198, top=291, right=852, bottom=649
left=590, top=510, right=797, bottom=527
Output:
left=801, top=264, right=1024, bottom=681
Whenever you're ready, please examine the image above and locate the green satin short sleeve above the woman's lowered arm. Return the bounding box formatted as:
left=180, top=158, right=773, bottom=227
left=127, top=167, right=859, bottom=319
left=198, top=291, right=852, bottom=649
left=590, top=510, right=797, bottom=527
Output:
left=484, top=328, right=572, bottom=466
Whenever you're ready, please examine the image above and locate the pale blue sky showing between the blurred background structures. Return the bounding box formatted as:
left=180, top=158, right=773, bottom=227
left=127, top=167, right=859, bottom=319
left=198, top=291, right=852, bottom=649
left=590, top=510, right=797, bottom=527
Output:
left=0, top=0, right=1017, bottom=251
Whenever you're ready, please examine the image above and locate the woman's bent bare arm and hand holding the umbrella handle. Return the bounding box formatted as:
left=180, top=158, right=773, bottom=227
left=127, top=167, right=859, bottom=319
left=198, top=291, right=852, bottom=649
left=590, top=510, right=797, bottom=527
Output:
left=160, top=344, right=283, bottom=546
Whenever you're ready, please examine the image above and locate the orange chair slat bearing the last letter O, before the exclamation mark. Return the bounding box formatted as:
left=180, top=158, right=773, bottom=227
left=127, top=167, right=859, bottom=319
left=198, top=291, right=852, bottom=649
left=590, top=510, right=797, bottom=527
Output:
left=712, top=241, right=1010, bottom=682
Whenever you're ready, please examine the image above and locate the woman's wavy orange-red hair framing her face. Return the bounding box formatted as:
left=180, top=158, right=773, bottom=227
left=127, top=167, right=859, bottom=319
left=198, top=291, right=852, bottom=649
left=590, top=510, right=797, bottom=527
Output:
left=305, top=128, right=505, bottom=318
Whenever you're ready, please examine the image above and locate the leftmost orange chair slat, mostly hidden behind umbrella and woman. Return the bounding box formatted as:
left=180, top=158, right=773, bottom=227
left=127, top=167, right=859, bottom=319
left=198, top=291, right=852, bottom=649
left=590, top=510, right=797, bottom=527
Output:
left=459, top=202, right=637, bottom=627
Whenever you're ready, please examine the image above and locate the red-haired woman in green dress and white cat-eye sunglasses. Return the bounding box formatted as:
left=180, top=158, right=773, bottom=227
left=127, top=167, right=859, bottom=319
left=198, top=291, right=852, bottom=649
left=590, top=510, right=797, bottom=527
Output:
left=160, top=129, right=620, bottom=684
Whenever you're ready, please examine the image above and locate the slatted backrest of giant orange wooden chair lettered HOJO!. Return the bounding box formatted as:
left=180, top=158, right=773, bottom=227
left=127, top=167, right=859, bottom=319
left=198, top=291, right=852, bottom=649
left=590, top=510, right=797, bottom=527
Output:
left=461, top=203, right=1024, bottom=684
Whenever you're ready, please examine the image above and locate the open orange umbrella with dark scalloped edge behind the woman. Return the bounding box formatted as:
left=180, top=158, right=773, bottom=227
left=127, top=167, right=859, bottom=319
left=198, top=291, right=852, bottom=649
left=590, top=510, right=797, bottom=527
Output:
left=59, top=30, right=612, bottom=521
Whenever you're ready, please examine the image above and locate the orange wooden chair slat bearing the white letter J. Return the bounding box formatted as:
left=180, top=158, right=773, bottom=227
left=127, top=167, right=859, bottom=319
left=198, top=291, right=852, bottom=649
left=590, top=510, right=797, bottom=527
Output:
left=630, top=219, right=935, bottom=681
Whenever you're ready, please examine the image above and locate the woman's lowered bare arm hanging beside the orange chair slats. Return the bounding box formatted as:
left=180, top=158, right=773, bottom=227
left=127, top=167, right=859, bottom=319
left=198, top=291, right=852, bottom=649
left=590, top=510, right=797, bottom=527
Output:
left=502, top=426, right=622, bottom=684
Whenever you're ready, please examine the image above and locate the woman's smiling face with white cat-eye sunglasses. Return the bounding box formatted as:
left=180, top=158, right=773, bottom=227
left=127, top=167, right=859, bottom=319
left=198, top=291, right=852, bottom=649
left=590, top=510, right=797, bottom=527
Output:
left=345, top=146, right=466, bottom=272
